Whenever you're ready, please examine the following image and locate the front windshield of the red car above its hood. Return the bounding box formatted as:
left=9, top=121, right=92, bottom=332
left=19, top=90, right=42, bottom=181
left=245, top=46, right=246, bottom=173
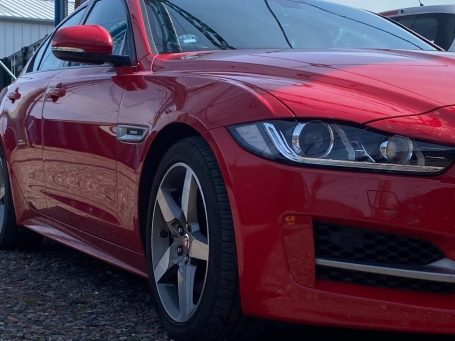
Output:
left=146, top=0, right=435, bottom=53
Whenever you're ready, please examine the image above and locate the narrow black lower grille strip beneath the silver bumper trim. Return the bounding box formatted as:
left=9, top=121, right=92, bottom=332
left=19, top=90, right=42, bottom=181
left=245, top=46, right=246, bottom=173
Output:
left=316, top=266, right=455, bottom=294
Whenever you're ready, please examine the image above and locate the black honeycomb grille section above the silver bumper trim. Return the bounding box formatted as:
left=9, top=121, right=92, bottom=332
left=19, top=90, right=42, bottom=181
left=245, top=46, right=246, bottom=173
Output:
left=314, top=223, right=445, bottom=266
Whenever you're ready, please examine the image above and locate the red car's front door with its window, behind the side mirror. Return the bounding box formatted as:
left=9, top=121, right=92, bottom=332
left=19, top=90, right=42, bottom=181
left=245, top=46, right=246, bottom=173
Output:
left=43, top=0, right=134, bottom=246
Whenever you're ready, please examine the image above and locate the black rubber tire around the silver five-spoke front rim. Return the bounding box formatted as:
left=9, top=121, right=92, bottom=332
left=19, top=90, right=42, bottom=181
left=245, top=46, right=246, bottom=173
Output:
left=146, top=137, right=264, bottom=341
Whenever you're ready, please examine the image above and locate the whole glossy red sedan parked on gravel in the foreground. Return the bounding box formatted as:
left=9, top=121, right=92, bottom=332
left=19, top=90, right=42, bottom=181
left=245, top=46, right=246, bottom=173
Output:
left=0, top=0, right=455, bottom=340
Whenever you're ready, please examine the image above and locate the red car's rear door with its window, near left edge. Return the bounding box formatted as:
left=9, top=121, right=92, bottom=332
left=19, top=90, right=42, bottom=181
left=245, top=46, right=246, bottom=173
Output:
left=2, top=7, right=85, bottom=220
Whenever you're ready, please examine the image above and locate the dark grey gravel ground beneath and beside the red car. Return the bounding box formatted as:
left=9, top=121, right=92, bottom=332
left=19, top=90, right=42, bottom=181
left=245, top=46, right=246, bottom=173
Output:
left=0, top=241, right=452, bottom=341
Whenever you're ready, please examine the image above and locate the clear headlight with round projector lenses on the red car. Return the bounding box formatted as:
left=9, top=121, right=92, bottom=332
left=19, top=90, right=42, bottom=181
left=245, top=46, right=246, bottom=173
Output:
left=229, top=121, right=455, bottom=174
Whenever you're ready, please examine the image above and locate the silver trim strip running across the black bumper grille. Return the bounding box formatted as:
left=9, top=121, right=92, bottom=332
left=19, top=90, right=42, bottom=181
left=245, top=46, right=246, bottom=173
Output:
left=316, top=258, right=455, bottom=284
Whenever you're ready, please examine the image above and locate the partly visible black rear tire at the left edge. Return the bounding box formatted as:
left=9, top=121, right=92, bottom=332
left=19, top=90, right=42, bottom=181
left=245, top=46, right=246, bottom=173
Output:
left=0, top=148, right=42, bottom=250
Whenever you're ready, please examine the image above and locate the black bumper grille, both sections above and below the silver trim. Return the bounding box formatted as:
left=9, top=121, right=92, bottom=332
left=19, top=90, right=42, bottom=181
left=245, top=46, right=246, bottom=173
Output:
left=314, top=223, right=455, bottom=294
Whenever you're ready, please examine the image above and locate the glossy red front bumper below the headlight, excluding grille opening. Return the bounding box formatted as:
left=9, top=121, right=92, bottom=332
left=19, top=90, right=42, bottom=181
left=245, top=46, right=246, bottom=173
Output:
left=206, top=128, right=455, bottom=333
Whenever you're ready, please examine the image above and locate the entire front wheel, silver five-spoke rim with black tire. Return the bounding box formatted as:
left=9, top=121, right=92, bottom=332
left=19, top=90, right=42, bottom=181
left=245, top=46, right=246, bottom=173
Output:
left=147, top=137, right=260, bottom=340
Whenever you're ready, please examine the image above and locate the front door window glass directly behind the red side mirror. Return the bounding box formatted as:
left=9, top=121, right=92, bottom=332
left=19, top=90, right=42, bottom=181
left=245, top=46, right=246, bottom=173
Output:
left=85, top=0, right=132, bottom=56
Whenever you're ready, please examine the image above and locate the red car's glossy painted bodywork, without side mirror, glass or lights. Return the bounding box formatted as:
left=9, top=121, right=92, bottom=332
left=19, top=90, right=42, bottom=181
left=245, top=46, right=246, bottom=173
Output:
left=0, top=0, right=455, bottom=333
